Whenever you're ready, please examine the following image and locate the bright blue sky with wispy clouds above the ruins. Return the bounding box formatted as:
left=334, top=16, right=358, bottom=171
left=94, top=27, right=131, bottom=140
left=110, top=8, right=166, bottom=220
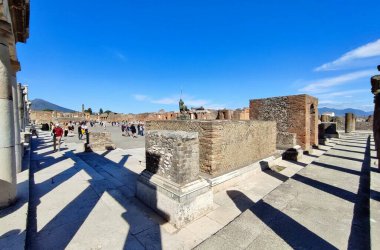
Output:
left=18, top=0, right=380, bottom=113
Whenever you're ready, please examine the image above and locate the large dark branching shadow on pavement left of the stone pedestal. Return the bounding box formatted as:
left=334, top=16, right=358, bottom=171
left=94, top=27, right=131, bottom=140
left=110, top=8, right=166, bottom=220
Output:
left=26, top=130, right=162, bottom=249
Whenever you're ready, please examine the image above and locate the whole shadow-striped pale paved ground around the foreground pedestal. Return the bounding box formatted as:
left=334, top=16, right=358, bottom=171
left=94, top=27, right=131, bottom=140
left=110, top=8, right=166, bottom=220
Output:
left=20, top=132, right=374, bottom=249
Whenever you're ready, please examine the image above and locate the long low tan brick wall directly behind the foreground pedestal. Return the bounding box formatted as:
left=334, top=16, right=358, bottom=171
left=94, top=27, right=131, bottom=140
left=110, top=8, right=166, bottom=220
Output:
left=146, top=120, right=277, bottom=176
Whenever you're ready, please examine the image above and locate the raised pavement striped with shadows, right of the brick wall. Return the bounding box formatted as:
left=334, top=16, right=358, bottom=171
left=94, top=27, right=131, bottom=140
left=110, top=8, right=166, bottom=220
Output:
left=196, top=133, right=379, bottom=249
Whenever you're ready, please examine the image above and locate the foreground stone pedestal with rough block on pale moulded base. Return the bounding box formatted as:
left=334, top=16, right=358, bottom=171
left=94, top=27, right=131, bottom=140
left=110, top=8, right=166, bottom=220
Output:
left=136, top=130, right=213, bottom=228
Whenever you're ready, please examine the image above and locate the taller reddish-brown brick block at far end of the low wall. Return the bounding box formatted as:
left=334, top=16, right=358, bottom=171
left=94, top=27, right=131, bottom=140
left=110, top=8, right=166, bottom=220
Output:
left=249, top=95, right=318, bottom=150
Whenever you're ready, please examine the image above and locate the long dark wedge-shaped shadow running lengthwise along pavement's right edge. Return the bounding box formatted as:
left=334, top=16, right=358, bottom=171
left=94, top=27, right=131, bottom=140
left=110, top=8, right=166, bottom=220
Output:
left=348, top=136, right=371, bottom=249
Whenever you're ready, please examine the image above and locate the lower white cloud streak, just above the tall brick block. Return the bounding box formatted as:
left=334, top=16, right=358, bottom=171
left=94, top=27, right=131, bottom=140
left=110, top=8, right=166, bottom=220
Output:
left=298, top=70, right=377, bottom=94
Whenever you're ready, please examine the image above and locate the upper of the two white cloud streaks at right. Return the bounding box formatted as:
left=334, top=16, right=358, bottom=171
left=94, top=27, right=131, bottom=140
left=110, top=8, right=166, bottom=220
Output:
left=315, top=39, right=380, bottom=71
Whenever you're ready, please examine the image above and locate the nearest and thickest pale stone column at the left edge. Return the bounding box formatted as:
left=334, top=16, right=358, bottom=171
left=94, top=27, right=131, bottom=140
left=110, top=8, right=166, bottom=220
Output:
left=0, top=20, right=17, bottom=207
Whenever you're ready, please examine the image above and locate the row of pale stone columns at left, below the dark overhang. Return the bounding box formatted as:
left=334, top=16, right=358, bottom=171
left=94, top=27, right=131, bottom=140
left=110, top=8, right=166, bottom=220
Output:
left=0, top=19, right=29, bottom=208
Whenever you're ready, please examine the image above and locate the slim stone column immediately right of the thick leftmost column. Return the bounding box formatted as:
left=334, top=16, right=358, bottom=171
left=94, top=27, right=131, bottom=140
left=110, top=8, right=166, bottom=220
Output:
left=11, top=62, right=23, bottom=173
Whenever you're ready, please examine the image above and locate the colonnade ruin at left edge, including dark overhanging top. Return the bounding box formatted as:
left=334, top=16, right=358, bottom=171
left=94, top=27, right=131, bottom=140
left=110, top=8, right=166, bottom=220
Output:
left=0, top=1, right=29, bottom=207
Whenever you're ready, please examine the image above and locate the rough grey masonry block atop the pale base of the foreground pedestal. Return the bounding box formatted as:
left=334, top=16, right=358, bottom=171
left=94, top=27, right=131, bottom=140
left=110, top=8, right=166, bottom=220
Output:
left=145, top=130, right=199, bottom=185
